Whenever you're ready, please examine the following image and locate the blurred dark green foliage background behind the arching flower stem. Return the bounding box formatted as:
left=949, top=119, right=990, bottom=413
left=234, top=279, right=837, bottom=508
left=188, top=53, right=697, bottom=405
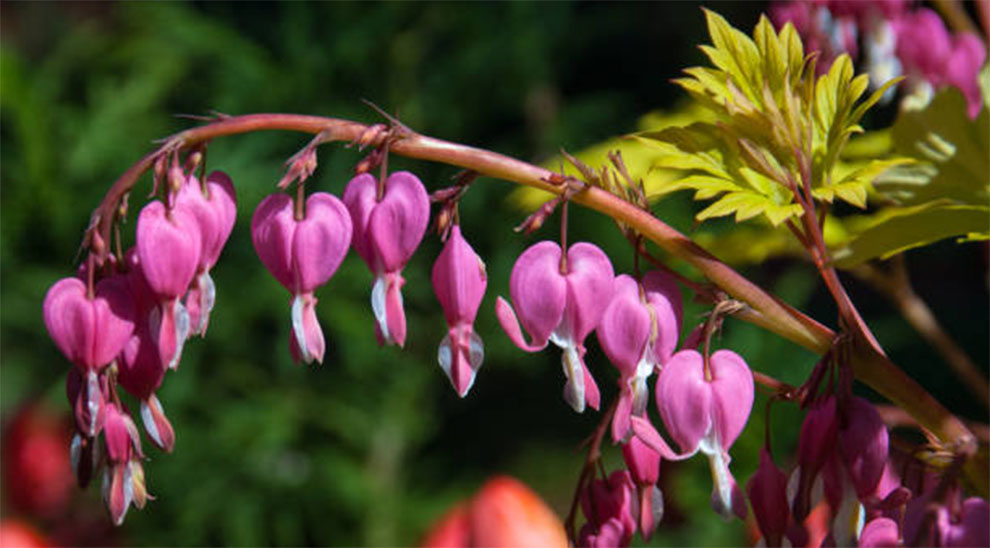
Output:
left=0, top=2, right=988, bottom=545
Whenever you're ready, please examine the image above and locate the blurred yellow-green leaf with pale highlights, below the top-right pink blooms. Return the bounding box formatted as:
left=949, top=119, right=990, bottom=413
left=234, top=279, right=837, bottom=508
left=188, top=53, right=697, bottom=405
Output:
left=875, top=88, right=990, bottom=205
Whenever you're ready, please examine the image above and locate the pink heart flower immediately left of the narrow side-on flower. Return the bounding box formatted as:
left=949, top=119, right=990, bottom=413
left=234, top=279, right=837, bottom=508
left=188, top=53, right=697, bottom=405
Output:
left=343, top=171, right=430, bottom=346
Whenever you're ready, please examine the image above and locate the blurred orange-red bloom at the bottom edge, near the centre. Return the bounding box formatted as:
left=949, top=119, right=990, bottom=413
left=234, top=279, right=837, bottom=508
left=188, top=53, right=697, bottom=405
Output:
left=421, top=476, right=567, bottom=548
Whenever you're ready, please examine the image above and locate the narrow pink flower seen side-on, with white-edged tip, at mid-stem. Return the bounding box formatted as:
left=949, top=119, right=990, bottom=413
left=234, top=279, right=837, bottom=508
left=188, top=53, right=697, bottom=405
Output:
left=432, top=225, right=488, bottom=398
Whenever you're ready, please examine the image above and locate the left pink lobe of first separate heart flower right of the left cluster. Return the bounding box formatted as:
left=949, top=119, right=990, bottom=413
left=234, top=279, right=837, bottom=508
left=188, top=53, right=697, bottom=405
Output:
left=251, top=193, right=296, bottom=291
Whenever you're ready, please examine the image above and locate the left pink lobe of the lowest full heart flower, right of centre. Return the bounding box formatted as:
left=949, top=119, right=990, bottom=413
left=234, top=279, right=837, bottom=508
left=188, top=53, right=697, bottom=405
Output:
left=656, top=350, right=712, bottom=453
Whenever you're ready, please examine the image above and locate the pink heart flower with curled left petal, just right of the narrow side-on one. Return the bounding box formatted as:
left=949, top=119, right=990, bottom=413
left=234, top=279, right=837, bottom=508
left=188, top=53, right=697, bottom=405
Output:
left=495, top=241, right=615, bottom=413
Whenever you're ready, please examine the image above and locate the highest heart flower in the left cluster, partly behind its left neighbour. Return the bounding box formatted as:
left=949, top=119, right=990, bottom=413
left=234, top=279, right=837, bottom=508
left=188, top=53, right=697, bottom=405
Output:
left=176, top=171, right=237, bottom=335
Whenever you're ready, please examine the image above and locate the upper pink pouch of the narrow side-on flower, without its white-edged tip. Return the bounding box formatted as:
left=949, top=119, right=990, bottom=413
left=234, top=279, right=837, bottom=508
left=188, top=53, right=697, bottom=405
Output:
left=431, top=225, right=488, bottom=326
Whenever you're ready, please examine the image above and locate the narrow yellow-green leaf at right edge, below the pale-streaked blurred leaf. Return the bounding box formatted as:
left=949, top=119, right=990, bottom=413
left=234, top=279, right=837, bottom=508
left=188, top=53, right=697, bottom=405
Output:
left=832, top=202, right=990, bottom=268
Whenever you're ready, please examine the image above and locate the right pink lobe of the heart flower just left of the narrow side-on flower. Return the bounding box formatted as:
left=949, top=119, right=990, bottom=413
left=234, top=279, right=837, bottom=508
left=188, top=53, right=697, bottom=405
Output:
left=367, top=171, right=430, bottom=272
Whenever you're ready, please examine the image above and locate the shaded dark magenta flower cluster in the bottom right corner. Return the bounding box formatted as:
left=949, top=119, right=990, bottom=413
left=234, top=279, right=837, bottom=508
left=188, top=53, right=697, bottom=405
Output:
left=746, top=394, right=990, bottom=546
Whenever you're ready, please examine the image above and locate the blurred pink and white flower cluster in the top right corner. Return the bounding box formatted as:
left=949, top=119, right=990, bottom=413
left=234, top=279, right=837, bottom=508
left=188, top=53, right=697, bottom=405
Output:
left=770, top=0, right=987, bottom=118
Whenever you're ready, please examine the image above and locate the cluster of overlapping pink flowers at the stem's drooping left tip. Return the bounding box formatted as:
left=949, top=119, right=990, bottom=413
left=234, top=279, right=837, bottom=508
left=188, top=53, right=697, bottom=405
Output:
left=43, top=169, right=236, bottom=524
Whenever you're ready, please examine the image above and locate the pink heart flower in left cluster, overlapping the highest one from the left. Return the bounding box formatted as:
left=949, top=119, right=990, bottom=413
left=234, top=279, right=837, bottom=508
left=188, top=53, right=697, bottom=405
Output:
left=136, top=200, right=202, bottom=369
